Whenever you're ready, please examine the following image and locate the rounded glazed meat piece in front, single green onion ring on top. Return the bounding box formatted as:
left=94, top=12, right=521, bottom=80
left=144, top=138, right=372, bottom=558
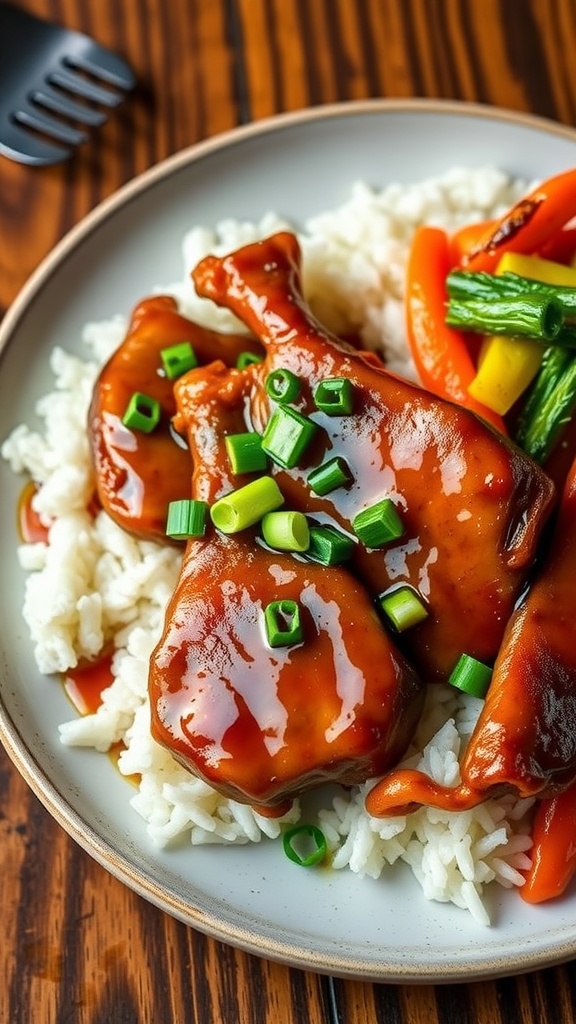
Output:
left=149, top=364, right=423, bottom=813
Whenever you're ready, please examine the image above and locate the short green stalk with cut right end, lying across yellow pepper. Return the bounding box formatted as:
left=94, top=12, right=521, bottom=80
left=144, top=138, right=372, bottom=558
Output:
left=446, top=293, right=564, bottom=341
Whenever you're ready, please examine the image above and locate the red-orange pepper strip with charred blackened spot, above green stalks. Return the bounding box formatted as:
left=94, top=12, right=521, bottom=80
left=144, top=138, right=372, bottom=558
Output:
left=461, top=169, right=576, bottom=273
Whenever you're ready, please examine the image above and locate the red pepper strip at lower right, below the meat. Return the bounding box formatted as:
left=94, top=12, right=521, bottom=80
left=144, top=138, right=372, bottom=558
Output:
left=520, top=784, right=576, bottom=903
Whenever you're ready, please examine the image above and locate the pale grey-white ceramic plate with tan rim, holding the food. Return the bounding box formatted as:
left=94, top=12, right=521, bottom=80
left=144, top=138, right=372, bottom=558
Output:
left=0, top=100, right=576, bottom=982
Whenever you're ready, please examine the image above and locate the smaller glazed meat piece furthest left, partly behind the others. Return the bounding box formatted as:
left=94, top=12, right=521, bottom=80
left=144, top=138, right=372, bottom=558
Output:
left=88, top=295, right=259, bottom=542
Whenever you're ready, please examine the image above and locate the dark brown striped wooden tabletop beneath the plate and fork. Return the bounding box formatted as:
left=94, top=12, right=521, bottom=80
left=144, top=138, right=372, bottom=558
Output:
left=0, top=0, right=576, bottom=1024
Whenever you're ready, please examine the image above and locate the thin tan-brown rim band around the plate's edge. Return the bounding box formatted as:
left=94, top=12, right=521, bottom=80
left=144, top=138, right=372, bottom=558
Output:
left=0, top=98, right=576, bottom=984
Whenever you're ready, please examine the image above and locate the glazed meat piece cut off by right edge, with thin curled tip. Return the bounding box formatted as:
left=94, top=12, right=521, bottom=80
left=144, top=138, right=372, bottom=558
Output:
left=366, top=463, right=576, bottom=815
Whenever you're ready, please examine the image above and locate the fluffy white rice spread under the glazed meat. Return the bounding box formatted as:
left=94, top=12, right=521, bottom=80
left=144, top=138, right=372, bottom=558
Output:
left=2, top=167, right=531, bottom=924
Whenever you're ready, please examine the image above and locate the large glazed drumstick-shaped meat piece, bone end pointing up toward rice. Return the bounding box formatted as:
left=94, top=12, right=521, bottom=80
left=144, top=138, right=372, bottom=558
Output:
left=193, top=232, right=553, bottom=681
